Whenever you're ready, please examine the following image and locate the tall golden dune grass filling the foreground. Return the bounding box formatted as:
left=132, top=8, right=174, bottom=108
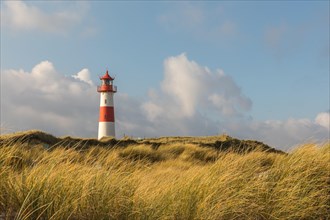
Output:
left=0, top=131, right=330, bottom=219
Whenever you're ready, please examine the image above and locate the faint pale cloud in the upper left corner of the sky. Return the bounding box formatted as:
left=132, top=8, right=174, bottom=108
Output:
left=1, top=1, right=88, bottom=33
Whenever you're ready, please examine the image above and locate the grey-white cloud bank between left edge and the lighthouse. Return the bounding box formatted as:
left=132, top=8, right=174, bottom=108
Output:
left=1, top=61, right=99, bottom=136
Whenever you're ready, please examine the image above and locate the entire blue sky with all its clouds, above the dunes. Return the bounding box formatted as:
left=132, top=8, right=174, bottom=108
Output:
left=0, top=1, right=330, bottom=150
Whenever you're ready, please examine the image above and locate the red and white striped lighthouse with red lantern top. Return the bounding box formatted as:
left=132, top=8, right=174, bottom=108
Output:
left=97, top=70, right=117, bottom=139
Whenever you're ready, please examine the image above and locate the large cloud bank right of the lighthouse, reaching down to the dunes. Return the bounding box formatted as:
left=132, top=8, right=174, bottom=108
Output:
left=135, top=54, right=329, bottom=149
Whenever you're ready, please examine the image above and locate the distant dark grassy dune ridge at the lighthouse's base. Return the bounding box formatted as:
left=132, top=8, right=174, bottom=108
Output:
left=0, top=130, right=283, bottom=153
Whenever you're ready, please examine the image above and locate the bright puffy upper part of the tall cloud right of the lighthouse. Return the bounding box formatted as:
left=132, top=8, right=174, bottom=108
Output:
left=142, top=54, right=252, bottom=121
